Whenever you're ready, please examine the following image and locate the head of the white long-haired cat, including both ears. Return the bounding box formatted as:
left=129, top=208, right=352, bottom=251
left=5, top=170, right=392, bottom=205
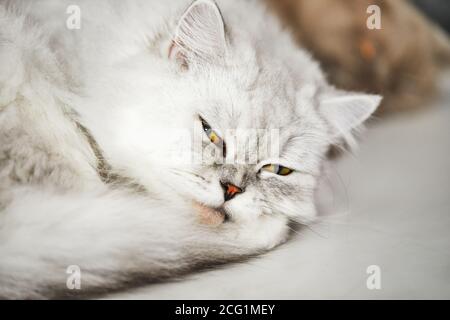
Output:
left=138, top=0, right=380, bottom=222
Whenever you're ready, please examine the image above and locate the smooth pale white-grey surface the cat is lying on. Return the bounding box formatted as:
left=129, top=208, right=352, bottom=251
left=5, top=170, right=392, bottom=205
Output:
left=108, top=86, right=450, bottom=299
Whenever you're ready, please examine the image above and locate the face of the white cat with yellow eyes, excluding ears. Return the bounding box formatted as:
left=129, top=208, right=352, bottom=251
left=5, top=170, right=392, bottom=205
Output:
left=164, top=62, right=329, bottom=221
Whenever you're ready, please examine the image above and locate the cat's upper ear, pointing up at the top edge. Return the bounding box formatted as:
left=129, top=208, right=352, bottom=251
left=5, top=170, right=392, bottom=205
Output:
left=168, top=0, right=226, bottom=66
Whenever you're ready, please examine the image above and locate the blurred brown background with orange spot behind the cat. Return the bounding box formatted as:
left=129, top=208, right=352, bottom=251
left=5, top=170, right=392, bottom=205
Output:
left=265, top=0, right=450, bottom=115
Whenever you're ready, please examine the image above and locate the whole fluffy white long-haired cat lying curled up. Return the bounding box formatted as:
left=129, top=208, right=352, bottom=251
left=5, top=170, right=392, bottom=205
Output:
left=0, top=0, right=381, bottom=298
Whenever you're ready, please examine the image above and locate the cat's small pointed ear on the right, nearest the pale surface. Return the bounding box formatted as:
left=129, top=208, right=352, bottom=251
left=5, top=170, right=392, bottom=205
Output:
left=319, top=90, right=382, bottom=139
